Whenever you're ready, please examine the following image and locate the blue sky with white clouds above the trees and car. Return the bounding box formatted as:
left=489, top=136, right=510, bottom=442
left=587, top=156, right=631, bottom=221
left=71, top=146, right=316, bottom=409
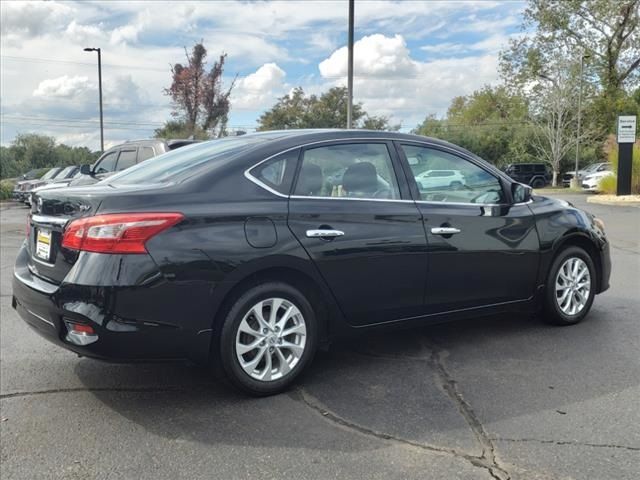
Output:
left=0, top=0, right=525, bottom=150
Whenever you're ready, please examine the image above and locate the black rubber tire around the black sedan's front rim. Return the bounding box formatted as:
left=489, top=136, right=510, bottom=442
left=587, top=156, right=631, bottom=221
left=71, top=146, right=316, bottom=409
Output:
left=544, top=247, right=598, bottom=326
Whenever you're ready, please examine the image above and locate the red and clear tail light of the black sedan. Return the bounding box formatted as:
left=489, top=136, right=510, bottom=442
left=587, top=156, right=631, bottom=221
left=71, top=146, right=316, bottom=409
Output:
left=62, top=213, right=184, bottom=253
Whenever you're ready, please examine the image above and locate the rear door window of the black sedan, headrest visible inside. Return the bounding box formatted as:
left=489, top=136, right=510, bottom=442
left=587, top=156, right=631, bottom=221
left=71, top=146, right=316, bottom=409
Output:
left=294, top=143, right=400, bottom=199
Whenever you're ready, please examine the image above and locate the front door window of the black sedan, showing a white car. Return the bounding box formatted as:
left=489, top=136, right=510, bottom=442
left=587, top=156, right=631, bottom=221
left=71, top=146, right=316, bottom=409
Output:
left=402, top=145, right=504, bottom=204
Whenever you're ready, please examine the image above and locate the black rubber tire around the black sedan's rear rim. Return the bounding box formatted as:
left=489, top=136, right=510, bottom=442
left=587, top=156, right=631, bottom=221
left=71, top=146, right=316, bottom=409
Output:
left=218, top=281, right=318, bottom=396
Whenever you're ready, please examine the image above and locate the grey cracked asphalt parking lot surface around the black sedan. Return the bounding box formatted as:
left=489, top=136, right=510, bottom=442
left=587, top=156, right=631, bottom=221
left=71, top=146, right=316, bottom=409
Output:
left=0, top=195, right=640, bottom=480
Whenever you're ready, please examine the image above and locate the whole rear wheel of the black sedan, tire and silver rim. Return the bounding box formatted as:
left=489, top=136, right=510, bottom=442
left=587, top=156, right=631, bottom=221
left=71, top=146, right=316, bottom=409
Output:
left=220, top=282, right=317, bottom=396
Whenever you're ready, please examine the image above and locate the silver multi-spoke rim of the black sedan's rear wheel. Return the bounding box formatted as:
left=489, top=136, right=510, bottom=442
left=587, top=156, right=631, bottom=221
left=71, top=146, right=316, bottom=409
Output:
left=235, top=298, right=307, bottom=382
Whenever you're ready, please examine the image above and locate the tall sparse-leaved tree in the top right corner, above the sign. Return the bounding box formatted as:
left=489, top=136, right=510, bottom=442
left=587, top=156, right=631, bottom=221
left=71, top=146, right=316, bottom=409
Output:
left=500, top=0, right=640, bottom=133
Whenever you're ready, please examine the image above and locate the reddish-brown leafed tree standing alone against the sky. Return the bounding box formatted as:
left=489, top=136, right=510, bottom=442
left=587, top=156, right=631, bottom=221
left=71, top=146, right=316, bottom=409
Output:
left=164, top=43, right=235, bottom=136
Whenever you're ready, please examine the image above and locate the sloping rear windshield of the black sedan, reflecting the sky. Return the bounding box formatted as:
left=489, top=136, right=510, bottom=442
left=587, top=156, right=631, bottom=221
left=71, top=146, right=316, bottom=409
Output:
left=103, top=136, right=267, bottom=185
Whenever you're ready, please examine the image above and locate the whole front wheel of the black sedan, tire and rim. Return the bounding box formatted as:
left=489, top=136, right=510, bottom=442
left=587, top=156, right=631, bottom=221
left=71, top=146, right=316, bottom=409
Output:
left=545, top=247, right=597, bottom=325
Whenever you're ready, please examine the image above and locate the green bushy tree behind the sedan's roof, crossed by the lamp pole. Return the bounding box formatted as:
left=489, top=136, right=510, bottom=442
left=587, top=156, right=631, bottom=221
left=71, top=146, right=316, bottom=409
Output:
left=258, top=87, right=399, bottom=130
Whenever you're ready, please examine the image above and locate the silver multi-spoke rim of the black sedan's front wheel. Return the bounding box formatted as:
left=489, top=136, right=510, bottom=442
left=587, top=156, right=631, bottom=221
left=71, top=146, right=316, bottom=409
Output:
left=556, top=257, right=591, bottom=315
